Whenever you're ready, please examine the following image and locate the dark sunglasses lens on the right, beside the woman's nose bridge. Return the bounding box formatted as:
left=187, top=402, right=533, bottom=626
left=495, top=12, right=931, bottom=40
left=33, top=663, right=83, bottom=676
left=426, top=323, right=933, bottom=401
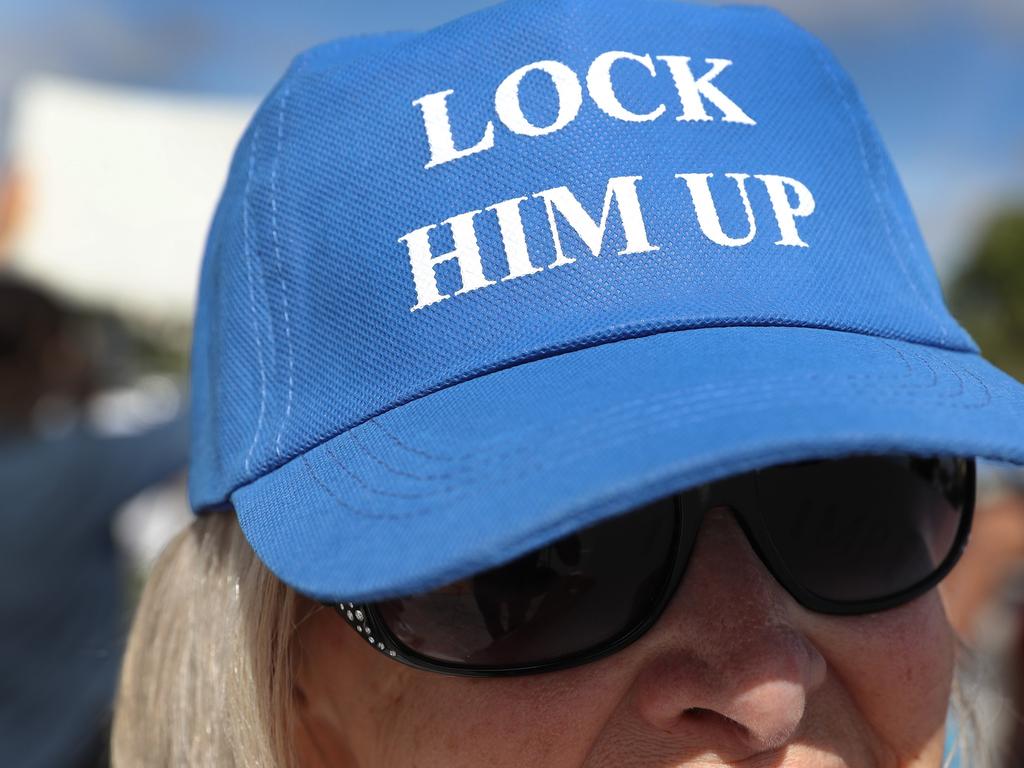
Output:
left=758, top=457, right=970, bottom=603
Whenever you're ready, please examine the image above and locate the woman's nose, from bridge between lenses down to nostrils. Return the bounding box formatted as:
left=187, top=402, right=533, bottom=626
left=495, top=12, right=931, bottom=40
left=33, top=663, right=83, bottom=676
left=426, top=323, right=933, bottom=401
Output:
left=633, top=508, right=826, bottom=761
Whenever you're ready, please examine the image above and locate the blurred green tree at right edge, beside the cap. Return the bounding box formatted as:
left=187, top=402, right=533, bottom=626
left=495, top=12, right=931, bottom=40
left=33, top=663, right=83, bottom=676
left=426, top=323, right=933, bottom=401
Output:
left=948, top=208, right=1024, bottom=381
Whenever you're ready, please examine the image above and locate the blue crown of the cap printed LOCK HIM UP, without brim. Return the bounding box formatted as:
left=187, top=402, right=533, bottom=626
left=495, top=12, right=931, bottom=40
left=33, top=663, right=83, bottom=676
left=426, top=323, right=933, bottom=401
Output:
left=194, top=1, right=973, bottom=504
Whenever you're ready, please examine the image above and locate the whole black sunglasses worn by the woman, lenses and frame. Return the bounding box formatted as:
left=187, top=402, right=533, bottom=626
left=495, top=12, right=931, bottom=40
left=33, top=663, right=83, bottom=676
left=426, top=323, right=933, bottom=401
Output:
left=334, top=456, right=975, bottom=677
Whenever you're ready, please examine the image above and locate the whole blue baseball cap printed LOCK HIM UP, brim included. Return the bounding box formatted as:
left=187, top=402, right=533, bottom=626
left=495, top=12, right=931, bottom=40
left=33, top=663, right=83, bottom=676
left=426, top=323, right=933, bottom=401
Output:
left=189, top=0, right=1024, bottom=600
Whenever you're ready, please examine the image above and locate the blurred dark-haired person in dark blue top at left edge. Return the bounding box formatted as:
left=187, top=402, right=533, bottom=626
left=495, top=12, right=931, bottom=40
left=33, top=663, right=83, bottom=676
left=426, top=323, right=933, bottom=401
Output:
left=0, top=274, right=186, bottom=768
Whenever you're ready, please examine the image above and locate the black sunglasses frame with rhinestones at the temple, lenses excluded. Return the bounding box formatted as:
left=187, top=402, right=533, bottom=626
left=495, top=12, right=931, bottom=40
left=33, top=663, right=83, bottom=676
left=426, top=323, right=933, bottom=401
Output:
left=325, top=458, right=977, bottom=678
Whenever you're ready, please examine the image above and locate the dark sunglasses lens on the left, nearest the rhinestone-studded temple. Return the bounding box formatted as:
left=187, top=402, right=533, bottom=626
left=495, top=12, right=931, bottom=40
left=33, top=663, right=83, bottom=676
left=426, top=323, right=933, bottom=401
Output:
left=377, top=498, right=678, bottom=668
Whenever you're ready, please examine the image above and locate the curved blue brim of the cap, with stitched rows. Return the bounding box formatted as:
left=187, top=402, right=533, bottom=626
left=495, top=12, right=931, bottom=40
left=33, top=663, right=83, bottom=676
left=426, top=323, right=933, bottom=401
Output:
left=231, top=327, right=1024, bottom=600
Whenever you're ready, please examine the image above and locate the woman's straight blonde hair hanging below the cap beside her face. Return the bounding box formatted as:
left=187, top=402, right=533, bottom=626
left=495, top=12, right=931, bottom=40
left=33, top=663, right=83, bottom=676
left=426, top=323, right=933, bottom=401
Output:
left=112, top=512, right=991, bottom=768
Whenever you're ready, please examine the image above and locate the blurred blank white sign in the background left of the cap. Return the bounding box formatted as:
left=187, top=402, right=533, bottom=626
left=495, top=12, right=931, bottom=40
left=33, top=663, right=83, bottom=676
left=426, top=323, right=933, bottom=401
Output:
left=7, top=76, right=255, bottom=322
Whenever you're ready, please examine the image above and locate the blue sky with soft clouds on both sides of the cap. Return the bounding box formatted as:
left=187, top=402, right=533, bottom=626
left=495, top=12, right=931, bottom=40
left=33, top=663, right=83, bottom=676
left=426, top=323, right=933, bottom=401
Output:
left=0, top=0, right=1024, bottom=273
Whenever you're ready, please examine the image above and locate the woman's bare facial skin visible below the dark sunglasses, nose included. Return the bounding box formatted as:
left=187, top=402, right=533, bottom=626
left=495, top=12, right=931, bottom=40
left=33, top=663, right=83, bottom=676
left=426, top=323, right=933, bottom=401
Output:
left=295, top=510, right=955, bottom=768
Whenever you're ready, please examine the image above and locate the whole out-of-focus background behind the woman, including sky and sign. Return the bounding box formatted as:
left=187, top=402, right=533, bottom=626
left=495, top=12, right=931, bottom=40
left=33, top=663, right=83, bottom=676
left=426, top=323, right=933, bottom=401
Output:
left=0, top=0, right=1024, bottom=766
